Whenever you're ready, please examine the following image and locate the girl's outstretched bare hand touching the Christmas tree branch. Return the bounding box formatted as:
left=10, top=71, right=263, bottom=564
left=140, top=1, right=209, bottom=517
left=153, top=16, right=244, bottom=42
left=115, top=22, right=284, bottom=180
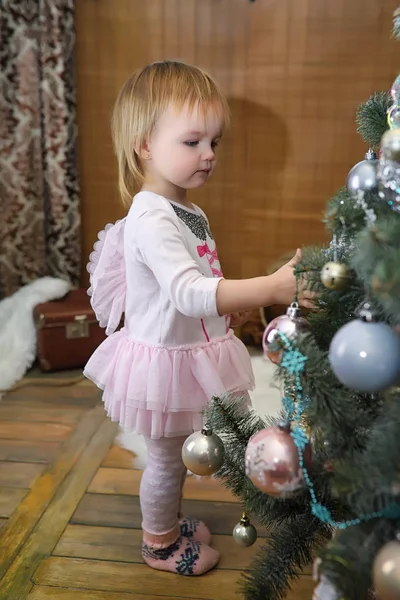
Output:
left=271, top=249, right=317, bottom=308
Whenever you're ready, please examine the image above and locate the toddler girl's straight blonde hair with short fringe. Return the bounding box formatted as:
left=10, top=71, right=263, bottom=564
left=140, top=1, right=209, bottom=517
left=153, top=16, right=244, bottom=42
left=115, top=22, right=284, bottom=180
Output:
left=111, top=61, right=230, bottom=205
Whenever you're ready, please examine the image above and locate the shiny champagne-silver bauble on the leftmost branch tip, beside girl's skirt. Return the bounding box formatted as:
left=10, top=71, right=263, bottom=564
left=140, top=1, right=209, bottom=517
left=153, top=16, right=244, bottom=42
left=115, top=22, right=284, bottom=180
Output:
left=182, top=426, right=225, bottom=475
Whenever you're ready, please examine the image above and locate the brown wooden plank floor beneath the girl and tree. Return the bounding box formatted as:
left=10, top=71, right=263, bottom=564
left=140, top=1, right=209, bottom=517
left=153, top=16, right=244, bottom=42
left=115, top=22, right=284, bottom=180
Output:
left=0, top=382, right=313, bottom=600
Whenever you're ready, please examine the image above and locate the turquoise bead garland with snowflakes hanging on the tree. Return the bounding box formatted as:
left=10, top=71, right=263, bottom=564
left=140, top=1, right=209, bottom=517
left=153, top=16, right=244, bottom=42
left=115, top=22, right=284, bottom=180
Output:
left=278, top=332, right=400, bottom=529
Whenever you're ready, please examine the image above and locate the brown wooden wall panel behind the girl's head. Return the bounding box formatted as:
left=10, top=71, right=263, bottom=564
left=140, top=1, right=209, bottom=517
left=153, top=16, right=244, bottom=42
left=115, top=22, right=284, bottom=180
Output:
left=76, top=0, right=400, bottom=277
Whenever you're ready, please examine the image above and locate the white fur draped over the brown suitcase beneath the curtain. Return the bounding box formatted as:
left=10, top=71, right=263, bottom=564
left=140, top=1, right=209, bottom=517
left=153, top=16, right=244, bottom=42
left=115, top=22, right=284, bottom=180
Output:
left=0, top=277, right=71, bottom=398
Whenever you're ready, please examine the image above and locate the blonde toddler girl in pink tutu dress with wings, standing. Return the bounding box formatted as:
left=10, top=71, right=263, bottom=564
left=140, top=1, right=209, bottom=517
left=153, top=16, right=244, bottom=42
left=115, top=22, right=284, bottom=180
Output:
left=85, top=61, right=316, bottom=575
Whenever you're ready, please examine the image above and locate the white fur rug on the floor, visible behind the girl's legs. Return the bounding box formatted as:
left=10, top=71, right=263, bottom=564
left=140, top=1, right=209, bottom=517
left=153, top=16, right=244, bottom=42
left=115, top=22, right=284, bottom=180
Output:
left=116, top=352, right=281, bottom=469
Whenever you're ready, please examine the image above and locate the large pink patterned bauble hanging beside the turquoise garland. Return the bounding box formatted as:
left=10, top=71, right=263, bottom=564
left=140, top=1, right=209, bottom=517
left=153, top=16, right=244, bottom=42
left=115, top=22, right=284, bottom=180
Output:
left=245, top=423, right=311, bottom=498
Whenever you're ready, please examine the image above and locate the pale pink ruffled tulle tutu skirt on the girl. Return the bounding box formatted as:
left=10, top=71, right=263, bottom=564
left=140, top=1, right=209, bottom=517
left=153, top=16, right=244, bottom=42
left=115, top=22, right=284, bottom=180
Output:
left=84, top=329, right=254, bottom=439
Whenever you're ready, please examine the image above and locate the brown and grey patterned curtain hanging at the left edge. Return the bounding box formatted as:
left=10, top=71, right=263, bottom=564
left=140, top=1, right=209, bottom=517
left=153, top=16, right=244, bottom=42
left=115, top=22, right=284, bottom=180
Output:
left=0, top=0, right=81, bottom=297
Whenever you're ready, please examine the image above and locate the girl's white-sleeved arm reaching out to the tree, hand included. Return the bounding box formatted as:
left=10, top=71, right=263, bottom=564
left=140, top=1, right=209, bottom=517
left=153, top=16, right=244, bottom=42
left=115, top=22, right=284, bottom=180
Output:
left=135, top=209, right=308, bottom=318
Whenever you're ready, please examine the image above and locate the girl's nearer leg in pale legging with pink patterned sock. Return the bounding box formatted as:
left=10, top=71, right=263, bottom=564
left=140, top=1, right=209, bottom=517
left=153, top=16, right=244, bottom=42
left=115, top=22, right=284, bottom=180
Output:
left=140, top=437, right=219, bottom=575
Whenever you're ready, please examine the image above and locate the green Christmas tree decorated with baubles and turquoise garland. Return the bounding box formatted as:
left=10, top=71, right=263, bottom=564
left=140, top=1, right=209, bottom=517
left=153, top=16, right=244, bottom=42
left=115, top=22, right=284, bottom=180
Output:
left=208, top=13, right=400, bottom=600
